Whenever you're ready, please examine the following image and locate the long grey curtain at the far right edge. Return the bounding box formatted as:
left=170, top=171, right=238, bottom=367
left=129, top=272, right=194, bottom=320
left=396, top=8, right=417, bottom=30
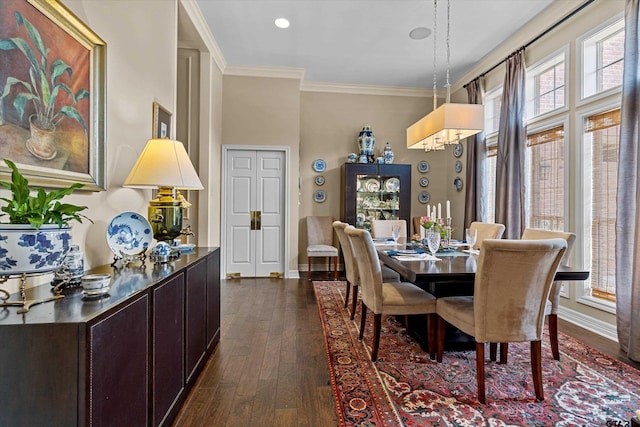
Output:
left=616, top=0, right=640, bottom=361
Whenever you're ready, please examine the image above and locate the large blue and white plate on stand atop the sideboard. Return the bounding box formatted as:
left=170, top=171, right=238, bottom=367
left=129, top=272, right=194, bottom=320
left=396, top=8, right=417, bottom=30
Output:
left=107, top=212, right=153, bottom=257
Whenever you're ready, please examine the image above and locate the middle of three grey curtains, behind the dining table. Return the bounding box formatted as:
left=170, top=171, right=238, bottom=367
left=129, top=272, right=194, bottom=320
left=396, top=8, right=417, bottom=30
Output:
left=495, top=48, right=527, bottom=239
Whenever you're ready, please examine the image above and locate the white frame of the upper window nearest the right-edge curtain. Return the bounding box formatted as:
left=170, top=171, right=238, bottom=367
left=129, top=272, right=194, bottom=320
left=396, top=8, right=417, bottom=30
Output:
left=575, top=13, right=625, bottom=107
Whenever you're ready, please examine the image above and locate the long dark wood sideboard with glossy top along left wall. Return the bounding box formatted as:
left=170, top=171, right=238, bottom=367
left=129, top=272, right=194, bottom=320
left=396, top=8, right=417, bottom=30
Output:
left=0, top=248, right=220, bottom=427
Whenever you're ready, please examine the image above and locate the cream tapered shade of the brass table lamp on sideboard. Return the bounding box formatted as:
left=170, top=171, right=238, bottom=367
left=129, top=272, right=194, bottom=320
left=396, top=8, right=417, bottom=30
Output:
left=124, top=139, right=204, bottom=190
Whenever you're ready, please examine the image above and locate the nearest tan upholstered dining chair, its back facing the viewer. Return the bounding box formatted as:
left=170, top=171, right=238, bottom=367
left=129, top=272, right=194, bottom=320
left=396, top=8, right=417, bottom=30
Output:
left=436, top=239, right=567, bottom=403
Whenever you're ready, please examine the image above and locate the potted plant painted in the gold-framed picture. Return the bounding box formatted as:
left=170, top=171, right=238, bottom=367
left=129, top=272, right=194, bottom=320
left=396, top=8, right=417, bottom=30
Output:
left=0, top=12, right=89, bottom=159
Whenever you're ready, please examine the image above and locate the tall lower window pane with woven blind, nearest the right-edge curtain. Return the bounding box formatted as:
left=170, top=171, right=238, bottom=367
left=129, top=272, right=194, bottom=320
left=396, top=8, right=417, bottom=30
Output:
left=583, top=109, right=620, bottom=301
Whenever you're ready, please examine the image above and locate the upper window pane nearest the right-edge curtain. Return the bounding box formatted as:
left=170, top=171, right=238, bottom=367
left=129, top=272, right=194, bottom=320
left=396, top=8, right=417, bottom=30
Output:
left=581, top=19, right=624, bottom=99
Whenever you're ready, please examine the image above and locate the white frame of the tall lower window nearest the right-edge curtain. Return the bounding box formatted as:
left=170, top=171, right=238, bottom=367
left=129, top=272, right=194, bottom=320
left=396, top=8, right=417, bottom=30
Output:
left=573, top=99, right=621, bottom=314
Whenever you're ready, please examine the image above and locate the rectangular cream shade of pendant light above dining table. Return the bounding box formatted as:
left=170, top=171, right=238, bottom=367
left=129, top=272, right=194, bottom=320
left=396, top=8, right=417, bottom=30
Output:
left=407, top=103, right=484, bottom=151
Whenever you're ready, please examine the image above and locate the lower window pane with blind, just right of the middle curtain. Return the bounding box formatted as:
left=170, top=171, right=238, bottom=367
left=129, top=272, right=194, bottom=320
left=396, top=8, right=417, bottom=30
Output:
left=525, top=125, right=565, bottom=231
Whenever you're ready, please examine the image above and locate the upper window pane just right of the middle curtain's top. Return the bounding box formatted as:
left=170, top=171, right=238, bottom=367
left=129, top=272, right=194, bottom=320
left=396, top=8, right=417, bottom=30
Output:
left=526, top=52, right=566, bottom=119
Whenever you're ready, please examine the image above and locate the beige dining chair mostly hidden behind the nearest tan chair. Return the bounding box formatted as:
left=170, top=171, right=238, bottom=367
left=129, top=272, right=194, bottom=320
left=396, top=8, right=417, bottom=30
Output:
left=522, top=228, right=576, bottom=360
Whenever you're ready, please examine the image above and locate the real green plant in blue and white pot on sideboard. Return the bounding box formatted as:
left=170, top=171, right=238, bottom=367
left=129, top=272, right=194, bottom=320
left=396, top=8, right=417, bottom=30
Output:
left=0, top=159, right=91, bottom=276
